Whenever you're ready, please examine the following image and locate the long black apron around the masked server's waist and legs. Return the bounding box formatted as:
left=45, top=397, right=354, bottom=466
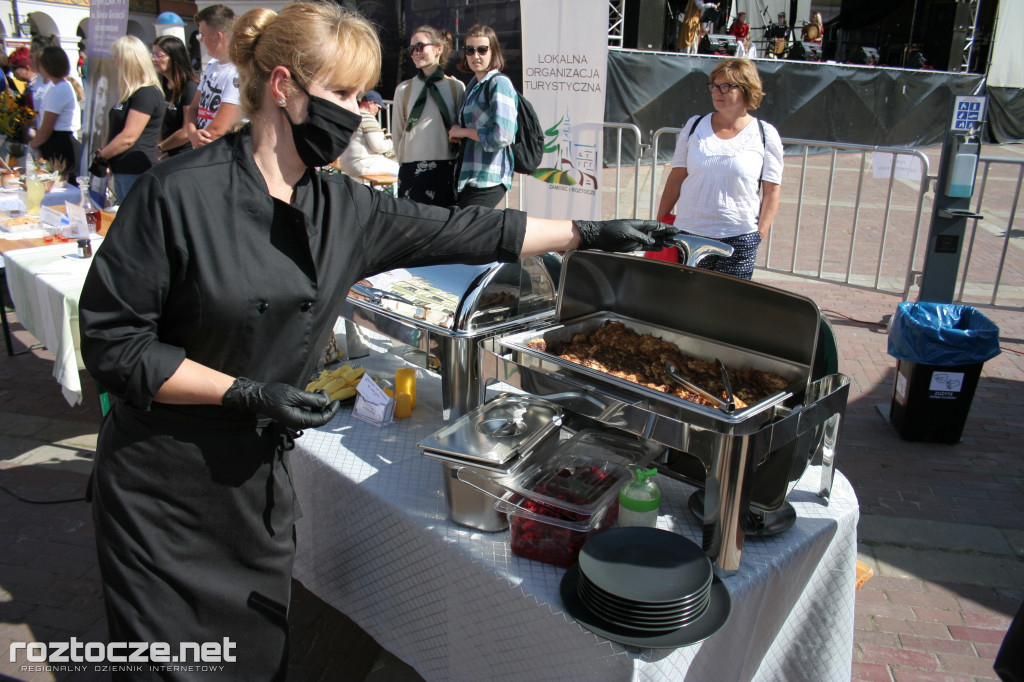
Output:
left=92, top=401, right=296, bottom=681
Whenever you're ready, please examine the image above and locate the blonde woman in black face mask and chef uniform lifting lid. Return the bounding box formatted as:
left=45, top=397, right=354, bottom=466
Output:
left=80, top=3, right=674, bottom=680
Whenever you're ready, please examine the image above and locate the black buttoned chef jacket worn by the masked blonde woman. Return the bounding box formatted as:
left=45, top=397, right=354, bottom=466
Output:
left=79, top=130, right=525, bottom=403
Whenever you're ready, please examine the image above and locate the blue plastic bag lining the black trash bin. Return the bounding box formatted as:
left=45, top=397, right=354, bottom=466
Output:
left=889, top=301, right=999, bottom=367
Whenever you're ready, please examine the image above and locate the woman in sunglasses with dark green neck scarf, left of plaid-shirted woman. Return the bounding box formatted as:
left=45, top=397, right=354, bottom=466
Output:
left=391, top=26, right=466, bottom=206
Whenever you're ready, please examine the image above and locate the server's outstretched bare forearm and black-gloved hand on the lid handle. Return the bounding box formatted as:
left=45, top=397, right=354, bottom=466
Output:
left=520, top=217, right=679, bottom=257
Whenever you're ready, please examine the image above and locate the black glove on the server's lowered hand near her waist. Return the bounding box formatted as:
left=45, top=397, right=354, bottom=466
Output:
left=221, top=377, right=341, bottom=429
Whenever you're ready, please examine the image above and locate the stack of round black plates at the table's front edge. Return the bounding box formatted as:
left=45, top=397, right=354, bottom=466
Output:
left=561, top=527, right=732, bottom=648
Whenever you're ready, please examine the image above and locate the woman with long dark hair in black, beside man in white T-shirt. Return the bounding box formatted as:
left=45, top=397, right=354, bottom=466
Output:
left=153, top=36, right=199, bottom=157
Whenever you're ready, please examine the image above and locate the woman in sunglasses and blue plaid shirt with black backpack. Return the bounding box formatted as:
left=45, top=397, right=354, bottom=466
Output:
left=449, top=25, right=517, bottom=208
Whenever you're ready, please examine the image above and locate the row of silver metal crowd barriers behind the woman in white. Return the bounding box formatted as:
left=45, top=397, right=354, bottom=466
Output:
left=378, top=112, right=1024, bottom=307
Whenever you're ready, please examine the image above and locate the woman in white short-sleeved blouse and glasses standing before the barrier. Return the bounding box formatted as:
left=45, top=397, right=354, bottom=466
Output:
left=655, top=59, right=782, bottom=280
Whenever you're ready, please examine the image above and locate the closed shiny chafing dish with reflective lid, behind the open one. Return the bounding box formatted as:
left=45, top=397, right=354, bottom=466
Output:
left=343, top=254, right=560, bottom=420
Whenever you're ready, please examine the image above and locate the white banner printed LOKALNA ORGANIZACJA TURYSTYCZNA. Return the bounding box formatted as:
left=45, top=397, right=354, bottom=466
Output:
left=519, top=0, right=608, bottom=218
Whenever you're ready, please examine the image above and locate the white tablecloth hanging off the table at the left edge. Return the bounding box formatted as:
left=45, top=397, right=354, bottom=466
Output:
left=3, top=238, right=102, bottom=404
